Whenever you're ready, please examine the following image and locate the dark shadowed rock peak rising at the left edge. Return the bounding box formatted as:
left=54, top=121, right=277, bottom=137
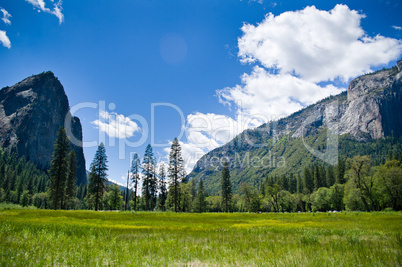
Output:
left=0, top=72, right=86, bottom=183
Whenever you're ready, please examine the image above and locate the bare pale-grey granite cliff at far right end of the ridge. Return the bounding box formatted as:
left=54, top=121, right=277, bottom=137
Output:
left=335, top=67, right=402, bottom=141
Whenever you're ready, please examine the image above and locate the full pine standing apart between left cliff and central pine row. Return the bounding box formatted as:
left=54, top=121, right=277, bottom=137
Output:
left=88, top=143, right=108, bottom=211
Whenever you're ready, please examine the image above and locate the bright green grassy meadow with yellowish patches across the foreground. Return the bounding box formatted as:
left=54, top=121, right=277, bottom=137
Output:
left=0, top=210, right=402, bottom=266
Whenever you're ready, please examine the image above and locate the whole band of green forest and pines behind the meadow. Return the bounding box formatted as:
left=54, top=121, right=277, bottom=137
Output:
left=0, top=128, right=402, bottom=212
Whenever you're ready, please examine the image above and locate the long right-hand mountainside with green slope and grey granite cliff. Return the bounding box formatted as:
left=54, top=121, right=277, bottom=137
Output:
left=189, top=61, right=402, bottom=193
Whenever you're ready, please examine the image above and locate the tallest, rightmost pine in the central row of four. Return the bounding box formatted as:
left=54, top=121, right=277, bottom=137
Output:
left=168, top=138, right=185, bottom=212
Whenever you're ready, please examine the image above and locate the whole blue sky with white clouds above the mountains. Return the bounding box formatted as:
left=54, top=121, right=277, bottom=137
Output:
left=0, top=0, right=402, bottom=186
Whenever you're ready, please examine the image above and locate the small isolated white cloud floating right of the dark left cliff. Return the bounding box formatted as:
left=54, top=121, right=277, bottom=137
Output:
left=92, top=111, right=140, bottom=139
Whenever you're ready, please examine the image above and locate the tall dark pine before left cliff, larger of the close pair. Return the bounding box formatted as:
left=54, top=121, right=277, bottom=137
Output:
left=49, top=126, right=70, bottom=210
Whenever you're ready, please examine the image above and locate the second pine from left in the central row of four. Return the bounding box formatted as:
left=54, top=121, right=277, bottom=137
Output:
left=141, top=145, right=156, bottom=210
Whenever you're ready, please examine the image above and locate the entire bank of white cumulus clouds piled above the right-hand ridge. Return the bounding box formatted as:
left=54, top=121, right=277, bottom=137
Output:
left=182, top=5, right=402, bottom=176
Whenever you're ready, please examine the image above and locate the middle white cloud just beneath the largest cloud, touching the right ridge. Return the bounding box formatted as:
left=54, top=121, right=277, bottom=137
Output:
left=217, top=66, right=342, bottom=122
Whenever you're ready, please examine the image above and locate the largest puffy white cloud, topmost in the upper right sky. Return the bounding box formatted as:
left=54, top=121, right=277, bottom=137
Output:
left=238, top=5, right=402, bottom=82
